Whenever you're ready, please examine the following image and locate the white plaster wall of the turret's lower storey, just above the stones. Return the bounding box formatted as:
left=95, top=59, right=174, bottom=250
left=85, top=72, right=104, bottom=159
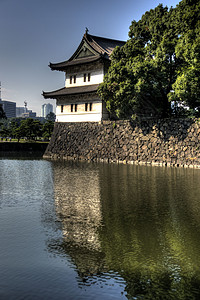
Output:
left=56, top=102, right=102, bottom=122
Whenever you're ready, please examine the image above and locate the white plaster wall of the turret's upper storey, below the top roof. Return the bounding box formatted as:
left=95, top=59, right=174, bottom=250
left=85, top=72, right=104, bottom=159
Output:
left=65, top=67, right=104, bottom=88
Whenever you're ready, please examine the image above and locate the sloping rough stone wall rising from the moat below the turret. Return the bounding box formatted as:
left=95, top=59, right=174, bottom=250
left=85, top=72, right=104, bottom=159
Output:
left=44, top=119, right=200, bottom=168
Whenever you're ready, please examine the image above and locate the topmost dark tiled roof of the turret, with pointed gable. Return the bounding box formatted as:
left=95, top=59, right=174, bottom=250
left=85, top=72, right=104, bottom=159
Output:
left=49, top=33, right=125, bottom=71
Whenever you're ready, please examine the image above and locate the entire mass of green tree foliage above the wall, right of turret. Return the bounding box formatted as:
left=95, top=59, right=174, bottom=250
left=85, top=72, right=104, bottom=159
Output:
left=99, top=0, right=200, bottom=118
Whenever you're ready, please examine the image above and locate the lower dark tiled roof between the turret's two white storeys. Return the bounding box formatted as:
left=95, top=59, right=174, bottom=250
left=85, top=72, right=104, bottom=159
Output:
left=43, top=84, right=99, bottom=99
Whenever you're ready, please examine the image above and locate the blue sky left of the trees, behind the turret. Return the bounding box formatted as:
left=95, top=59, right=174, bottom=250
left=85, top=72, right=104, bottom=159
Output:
left=0, top=0, right=179, bottom=115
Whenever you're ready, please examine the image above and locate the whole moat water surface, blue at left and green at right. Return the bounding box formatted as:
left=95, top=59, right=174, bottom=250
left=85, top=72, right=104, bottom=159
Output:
left=0, top=159, right=200, bottom=300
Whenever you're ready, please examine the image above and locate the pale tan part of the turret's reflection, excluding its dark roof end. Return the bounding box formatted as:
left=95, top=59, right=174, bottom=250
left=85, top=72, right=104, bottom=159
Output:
left=54, top=165, right=102, bottom=251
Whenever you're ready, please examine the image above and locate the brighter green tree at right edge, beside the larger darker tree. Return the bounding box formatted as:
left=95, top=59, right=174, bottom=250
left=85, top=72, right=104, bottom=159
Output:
left=169, top=0, right=200, bottom=115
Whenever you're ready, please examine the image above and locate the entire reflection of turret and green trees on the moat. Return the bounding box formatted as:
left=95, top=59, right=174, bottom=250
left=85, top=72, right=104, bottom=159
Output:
left=49, top=162, right=200, bottom=299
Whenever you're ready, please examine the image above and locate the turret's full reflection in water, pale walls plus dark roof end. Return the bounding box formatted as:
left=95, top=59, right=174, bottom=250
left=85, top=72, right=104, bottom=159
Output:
left=54, top=163, right=107, bottom=276
